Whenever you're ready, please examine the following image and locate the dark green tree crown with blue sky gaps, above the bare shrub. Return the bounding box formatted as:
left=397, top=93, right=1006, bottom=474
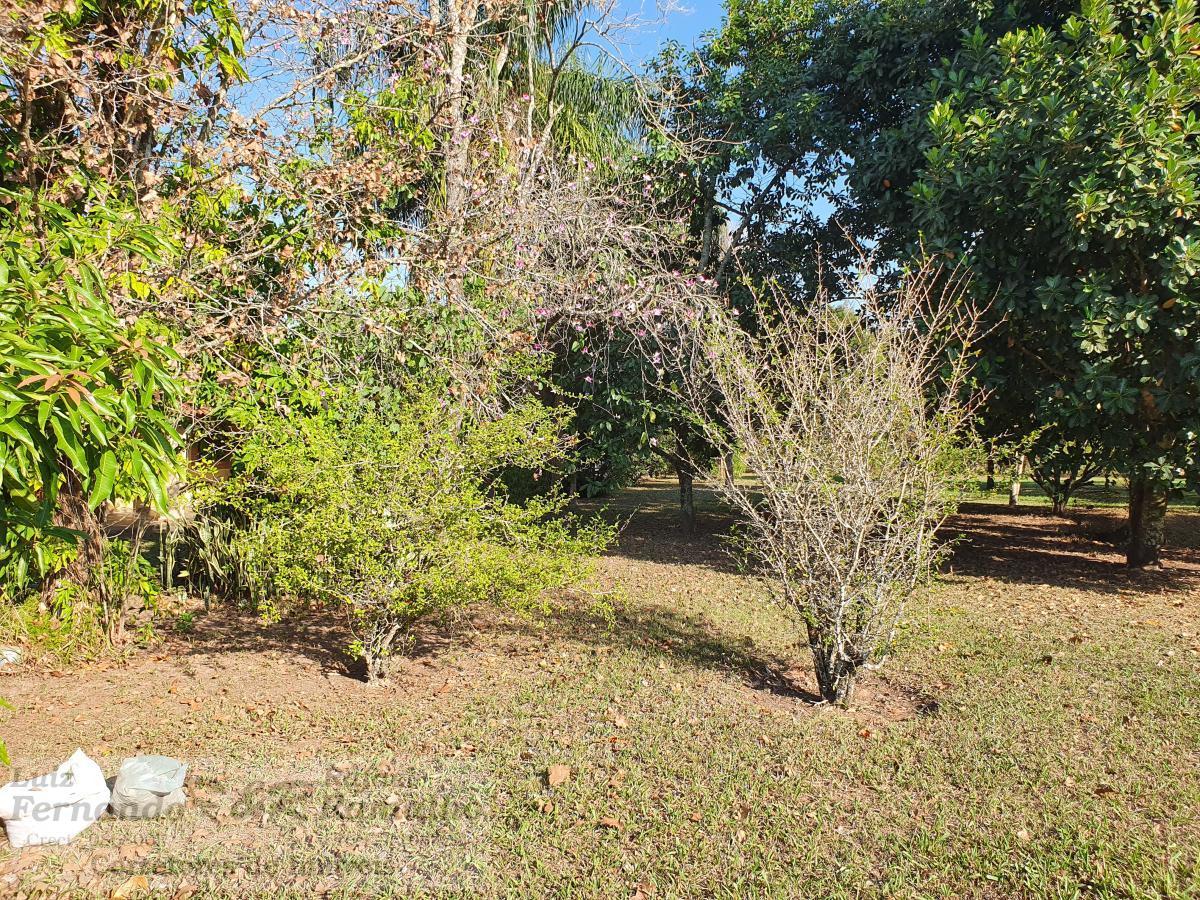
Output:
left=670, top=0, right=1074, bottom=290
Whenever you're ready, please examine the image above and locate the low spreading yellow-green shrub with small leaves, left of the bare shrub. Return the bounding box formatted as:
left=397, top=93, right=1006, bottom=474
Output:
left=230, top=391, right=611, bottom=680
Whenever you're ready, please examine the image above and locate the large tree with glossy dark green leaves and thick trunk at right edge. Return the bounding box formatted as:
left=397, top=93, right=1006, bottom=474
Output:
left=910, top=0, right=1200, bottom=565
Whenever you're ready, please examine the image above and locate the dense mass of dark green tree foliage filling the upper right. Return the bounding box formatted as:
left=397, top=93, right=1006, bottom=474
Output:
left=668, top=0, right=1200, bottom=562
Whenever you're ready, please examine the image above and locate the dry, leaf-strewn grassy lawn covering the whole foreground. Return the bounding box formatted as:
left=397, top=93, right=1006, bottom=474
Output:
left=0, top=482, right=1200, bottom=899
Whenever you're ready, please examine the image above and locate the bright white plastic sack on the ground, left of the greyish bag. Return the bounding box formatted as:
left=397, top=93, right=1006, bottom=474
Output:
left=0, top=750, right=109, bottom=847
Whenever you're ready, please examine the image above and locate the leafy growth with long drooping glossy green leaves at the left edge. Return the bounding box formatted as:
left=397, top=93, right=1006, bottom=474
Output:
left=0, top=191, right=179, bottom=595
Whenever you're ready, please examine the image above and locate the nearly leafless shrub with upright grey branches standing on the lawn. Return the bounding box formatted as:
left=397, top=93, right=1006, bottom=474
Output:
left=690, top=266, right=977, bottom=706
